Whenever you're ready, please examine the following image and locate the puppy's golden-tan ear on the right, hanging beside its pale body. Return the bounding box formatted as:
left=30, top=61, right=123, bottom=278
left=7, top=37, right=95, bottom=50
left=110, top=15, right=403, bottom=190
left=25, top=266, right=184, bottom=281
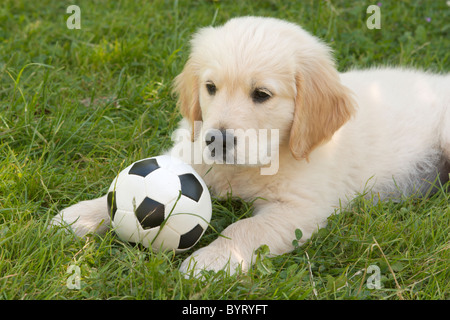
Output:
left=289, top=47, right=355, bottom=160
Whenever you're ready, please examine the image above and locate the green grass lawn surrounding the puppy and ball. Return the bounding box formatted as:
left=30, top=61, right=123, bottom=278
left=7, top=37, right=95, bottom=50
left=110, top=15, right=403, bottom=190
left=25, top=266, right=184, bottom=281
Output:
left=0, top=0, right=450, bottom=299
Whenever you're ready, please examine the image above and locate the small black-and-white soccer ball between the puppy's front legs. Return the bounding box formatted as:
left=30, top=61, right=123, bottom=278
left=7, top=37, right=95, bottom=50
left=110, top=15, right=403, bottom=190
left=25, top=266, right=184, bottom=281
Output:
left=107, top=155, right=212, bottom=252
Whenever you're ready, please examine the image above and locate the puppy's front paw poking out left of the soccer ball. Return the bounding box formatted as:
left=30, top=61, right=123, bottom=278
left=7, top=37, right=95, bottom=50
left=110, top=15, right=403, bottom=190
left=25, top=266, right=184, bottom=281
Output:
left=51, top=196, right=110, bottom=237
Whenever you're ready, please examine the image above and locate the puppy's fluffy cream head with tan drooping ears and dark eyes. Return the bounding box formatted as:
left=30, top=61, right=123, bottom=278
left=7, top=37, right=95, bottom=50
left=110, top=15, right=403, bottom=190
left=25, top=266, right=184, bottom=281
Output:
left=175, top=17, right=354, bottom=164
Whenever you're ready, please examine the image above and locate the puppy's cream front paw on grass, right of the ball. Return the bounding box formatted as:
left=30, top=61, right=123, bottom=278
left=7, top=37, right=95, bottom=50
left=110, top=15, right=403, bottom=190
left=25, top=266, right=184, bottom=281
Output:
left=180, top=245, right=248, bottom=278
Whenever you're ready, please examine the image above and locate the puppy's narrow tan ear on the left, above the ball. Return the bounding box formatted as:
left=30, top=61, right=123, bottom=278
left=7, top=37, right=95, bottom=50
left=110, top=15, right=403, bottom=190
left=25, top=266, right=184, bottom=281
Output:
left=174, top=59, right=202, bottom=141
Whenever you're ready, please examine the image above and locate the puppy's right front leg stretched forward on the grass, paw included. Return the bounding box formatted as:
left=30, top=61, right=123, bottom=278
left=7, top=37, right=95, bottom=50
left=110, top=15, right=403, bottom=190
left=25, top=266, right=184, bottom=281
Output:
left=180, top=203, right=320, bottom=276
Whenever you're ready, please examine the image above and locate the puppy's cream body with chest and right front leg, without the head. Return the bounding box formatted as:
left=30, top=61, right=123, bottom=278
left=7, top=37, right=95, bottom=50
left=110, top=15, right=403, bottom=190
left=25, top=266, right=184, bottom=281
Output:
left=173, top=69, right=450, bottom=270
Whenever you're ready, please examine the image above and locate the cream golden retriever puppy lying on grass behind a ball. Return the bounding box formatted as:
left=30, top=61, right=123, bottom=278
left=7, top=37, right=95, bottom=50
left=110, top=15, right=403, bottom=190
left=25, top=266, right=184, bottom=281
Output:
left=53, top=17, right=450, bottom=274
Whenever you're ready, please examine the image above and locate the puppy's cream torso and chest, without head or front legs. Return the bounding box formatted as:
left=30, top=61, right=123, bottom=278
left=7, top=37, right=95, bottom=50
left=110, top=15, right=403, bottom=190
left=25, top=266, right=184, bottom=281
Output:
left=196, top=68, right=450, bottom=203
